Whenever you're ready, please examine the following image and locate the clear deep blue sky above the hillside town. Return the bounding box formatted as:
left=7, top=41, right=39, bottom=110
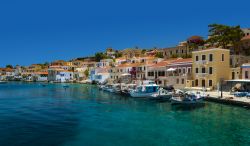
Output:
left=0, top=0, right=250, bottom=66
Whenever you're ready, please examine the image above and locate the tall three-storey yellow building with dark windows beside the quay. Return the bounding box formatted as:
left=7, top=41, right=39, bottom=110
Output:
left=192, top=48, right=231, bottom=89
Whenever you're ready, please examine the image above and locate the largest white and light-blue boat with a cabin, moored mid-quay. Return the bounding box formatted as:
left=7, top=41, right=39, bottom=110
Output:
left=130, top=84, right=159, bottom=98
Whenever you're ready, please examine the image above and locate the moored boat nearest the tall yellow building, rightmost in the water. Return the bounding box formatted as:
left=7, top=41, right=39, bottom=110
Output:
left=171, top=91, right=205, bottom=105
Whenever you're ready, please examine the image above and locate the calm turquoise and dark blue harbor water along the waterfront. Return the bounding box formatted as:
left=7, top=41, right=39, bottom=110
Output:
left=0, top=82, right=250, bottom=146
